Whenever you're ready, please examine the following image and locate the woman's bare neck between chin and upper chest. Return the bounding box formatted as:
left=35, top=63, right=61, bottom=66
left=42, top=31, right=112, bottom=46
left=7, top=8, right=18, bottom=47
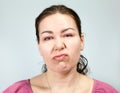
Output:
left=45, top=70, right=80, bottom=89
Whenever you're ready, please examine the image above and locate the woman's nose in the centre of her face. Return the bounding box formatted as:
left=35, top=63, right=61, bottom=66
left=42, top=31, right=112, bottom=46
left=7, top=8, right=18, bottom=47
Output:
left=54, top=38, right=66, bottom=51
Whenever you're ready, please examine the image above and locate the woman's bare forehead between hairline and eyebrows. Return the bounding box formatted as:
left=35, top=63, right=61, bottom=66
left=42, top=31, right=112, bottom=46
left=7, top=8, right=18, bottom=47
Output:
left=39, top=13, right=76, bottom=31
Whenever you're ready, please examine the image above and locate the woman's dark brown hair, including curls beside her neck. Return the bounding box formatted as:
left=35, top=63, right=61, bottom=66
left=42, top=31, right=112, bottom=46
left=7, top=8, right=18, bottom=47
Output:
left=35, top=5, right=88, bottom=75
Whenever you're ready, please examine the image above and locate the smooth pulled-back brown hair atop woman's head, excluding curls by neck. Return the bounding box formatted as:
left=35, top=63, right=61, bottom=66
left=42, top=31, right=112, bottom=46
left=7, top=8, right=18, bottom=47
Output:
left=35, top=5, right=82, bottom=43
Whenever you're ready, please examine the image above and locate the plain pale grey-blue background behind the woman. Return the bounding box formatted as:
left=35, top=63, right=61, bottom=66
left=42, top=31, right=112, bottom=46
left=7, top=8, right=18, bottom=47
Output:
left=0, top=0, right=120, bottom=92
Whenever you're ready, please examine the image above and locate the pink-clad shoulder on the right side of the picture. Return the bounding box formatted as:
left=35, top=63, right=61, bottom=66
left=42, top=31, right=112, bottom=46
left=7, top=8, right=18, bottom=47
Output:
left=92, top=80, right=118, bottom=93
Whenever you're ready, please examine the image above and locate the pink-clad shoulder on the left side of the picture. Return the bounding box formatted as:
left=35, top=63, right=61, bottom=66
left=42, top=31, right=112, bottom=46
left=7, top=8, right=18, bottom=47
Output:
left=3, top=80, right=32, bottom=93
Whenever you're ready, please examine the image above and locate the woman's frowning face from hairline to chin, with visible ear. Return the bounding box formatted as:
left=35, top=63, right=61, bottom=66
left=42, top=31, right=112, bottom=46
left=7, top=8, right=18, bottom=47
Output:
left=38, top=13, right=84, bottom=72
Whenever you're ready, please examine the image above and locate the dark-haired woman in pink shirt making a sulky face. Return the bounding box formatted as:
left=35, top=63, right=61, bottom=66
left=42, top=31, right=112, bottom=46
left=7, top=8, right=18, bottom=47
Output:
left=3, top=5, right=118, bottom=93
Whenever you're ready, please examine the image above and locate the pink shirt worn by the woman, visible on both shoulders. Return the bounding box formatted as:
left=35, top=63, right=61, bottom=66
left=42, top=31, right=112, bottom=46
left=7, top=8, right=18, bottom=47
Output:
left=3, top=80, right=118, bottom=93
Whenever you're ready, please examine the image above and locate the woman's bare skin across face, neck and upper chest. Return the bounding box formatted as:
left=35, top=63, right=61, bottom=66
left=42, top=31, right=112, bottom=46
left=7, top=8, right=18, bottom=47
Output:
left=30, top=13, right=93, bottom=93
